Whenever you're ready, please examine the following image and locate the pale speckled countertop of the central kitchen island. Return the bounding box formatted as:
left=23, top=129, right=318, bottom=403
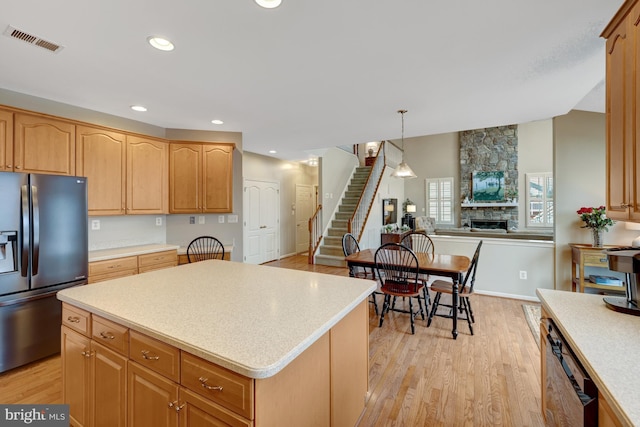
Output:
left=58, top=260, right=376, bottom=378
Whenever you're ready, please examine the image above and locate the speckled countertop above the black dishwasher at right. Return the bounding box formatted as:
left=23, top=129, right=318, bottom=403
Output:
left=536, top=289, right=640, bottom=426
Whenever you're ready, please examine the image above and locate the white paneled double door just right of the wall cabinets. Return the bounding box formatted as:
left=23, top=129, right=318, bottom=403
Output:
left=243, top=180, right=280, bottom=264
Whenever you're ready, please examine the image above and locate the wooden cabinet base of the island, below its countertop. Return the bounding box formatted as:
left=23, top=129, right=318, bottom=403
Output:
left=62, top=301, right=369, bottom=427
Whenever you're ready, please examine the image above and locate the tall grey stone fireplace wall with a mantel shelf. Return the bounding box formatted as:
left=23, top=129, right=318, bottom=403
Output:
left=460, top=125, right=518, bottom=229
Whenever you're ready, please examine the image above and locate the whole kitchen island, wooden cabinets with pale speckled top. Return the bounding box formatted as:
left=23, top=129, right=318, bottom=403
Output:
left=58, top=260, right=376, bottom=426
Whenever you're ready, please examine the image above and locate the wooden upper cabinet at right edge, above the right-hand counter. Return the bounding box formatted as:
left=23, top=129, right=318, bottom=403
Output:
left=602, top=0, right=640, bottom=222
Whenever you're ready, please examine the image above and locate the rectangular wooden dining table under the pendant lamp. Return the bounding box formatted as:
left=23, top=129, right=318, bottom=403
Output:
left=345, top=249, right=471, bottom=339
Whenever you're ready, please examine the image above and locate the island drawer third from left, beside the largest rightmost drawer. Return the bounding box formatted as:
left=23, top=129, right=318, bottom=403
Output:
left=129, top=331, right=180, bottom=382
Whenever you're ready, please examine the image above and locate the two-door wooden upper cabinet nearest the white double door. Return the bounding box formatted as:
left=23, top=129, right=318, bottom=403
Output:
left=169, top=143, right=234, bottom=213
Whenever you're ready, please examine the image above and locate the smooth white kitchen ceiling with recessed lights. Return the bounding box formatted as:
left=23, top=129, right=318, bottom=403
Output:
left=0, top=0, right=623, bottom=160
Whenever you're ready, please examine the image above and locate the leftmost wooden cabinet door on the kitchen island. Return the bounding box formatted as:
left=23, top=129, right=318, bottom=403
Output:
left=60, top=326, right=92, bottom=426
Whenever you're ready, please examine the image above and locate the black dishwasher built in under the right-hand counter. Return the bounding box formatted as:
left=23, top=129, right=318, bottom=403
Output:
left=542, top=319, right=598, bottom=427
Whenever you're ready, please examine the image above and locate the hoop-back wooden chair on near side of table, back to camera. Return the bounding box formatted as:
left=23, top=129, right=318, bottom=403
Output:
left=374, top=243, right=425, bottom=334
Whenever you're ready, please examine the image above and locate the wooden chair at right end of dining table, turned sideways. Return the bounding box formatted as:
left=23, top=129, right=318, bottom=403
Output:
left=427, top=240, right=482, bottom=335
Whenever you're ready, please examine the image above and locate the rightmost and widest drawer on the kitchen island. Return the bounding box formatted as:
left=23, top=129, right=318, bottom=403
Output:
left=180, top=352, right=254, bottom=420
